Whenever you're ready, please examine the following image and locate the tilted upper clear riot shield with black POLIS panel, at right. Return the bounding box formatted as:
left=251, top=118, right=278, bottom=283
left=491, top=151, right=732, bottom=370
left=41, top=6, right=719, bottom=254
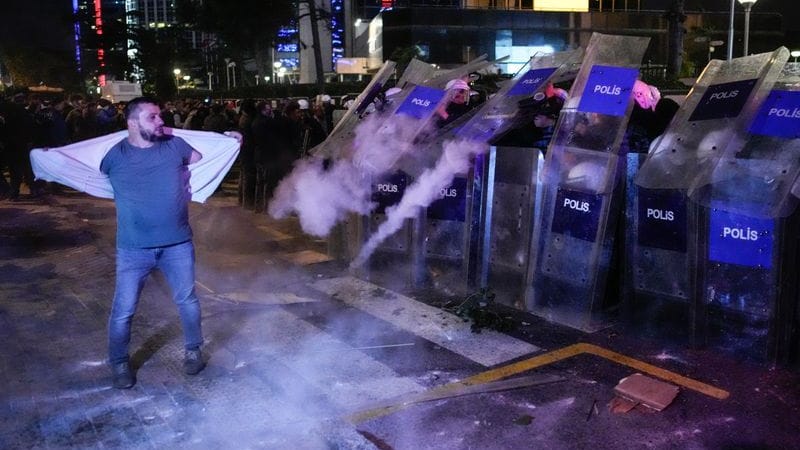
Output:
left=636, top=48, right=789, bottom=205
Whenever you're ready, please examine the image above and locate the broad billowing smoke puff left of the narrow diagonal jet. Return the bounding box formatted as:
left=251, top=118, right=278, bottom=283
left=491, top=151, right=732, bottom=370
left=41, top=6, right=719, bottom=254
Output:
left=268, top=113, right=432, bottom=236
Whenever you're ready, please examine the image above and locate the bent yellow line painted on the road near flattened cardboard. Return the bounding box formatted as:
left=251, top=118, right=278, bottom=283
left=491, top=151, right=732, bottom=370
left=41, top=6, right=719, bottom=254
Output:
left=347, top=343, right=730, bottom=424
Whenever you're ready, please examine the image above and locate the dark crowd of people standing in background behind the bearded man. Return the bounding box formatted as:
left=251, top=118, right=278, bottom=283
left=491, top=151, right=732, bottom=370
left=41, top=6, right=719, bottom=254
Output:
left=0, top=93, right=334, bottom=203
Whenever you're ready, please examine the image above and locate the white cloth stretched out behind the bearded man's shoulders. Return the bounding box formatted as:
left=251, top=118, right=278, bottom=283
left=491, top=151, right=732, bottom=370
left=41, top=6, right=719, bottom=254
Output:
left=31, top=128, right=239, bottom=203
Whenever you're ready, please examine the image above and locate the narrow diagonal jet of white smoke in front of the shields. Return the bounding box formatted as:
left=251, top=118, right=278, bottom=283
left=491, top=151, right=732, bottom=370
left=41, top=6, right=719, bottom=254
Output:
left=350, top=141, right=487, bottom=268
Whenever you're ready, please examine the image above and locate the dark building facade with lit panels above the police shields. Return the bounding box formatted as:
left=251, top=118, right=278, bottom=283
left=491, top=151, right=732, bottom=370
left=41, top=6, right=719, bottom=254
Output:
left=349, top=0, right=784, bottom=77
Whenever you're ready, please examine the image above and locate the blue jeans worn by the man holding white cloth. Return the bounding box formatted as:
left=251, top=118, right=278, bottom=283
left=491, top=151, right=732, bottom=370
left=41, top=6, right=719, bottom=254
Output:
left=108, top=241, right=203, bottom=364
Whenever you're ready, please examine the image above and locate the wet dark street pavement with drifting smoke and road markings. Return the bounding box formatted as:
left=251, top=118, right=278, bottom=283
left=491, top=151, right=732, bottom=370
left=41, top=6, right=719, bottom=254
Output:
left=0, top=180, right=800, bottom=450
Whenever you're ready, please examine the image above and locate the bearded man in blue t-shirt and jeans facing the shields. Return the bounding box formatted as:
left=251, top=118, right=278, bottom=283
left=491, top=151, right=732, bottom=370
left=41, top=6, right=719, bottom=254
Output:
left=100, top=97, right=205, bottom=389
